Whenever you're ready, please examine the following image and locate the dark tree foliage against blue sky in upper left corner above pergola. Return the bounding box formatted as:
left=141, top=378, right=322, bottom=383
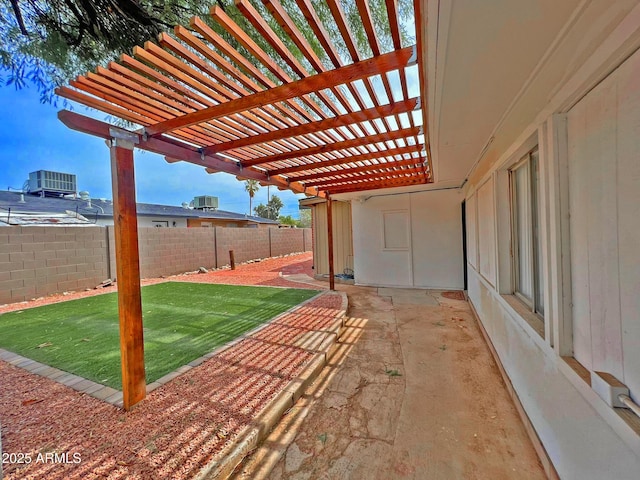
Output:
left=0, top=0, right=212, bottom=101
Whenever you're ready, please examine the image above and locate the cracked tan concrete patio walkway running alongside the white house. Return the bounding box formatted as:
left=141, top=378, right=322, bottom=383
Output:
left=234, top=286, right=545, bottom=479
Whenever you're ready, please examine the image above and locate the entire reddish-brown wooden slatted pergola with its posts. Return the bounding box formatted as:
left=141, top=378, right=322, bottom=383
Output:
left=57, top=0, right=432, bottom=409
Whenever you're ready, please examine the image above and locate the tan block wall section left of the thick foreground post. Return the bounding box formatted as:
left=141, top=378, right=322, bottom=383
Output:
left=0, top=227, right=109, bottom=304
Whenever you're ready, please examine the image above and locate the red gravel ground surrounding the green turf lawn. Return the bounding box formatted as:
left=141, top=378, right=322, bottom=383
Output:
left=0, top=254, right=341, bottom=480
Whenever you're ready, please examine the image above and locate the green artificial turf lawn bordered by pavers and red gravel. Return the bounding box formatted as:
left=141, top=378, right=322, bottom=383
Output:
left=0, top=282, right=318, bottom=390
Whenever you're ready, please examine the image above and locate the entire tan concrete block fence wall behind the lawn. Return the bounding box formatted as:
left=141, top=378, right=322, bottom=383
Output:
left=0, top=226, right=312, bottom=304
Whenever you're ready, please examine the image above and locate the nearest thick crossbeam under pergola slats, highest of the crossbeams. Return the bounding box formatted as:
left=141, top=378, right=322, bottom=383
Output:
left=145, top=47, right=415, bottom=136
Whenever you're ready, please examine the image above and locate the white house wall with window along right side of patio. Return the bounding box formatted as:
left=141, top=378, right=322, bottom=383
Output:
left=466, top=7, right=640, bottom=479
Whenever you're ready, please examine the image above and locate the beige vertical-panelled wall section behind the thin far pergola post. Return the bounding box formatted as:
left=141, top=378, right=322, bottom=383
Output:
left=311, top=201, right=353, bottom=275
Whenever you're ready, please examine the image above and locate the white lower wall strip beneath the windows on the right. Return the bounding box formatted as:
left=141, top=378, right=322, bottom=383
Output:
left=468, top=268, right=640, bottom=480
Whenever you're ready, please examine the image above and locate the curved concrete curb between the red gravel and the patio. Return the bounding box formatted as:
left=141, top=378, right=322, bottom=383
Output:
left=194, top=290, right=348, bottom=480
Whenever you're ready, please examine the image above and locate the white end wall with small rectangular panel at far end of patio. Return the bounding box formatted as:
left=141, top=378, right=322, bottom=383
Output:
left=352, top=189, right=464, bottom=289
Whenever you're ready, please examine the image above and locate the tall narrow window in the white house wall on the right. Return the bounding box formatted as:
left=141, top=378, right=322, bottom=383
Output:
left=509, top=148, right=544, bottom=315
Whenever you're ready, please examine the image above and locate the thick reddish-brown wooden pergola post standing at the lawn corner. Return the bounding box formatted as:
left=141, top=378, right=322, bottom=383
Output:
left=111, top=129, right=146, bottom=410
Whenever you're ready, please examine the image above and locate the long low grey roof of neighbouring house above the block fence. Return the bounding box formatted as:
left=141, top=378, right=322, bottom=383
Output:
left=0, top=191, right=278, bottom=225
